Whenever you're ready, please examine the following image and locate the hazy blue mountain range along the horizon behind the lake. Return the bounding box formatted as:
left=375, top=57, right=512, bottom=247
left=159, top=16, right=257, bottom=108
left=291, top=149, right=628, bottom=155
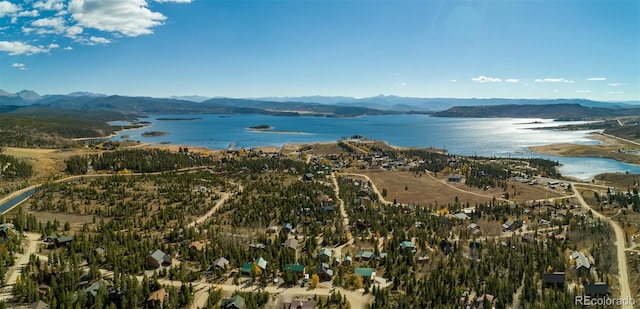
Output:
left=0, top=90, right=640, bottom=118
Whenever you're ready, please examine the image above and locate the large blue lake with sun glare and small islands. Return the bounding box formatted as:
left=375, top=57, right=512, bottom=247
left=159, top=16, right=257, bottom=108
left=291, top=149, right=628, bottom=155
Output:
left=113, top=115, right=640, bottom=179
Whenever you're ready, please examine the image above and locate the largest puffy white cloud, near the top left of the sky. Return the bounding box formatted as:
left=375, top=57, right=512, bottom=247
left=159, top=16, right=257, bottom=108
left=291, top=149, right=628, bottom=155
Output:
left=68, top=0, right=167, bottom=37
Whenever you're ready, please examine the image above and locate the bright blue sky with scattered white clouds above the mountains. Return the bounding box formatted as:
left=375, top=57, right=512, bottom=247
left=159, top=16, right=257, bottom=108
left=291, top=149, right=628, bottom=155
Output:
left=0, top=0, right=640, bottom=101
